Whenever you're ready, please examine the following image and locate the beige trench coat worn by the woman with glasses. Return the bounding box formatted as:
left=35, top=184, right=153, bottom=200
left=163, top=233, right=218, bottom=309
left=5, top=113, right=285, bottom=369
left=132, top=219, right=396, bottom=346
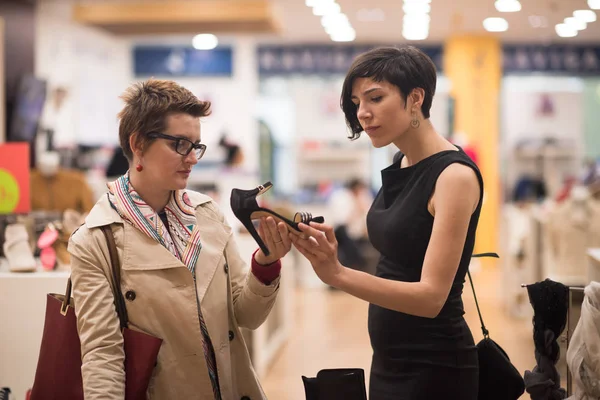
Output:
left=69, top=191, right=279, bottom=400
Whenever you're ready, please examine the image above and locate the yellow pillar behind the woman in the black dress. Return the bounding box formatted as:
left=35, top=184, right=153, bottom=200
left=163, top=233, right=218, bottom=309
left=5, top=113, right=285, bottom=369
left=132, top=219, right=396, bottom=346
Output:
left=444, top=36, right=502, bottom=262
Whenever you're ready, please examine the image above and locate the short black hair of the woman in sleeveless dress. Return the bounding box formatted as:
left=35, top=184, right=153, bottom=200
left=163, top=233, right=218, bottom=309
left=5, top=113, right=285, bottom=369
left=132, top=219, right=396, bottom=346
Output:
left=340, top=46, right=437, bottom=139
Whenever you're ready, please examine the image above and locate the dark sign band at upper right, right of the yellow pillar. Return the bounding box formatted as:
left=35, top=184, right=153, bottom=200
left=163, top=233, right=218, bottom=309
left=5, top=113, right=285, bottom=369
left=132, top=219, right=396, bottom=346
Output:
left=504, top=45, right=600, bottom=75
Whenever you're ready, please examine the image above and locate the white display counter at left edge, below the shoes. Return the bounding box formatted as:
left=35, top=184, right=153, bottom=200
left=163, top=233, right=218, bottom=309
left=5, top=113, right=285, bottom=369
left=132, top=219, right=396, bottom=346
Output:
left=0, top=260, right=69, bottom=400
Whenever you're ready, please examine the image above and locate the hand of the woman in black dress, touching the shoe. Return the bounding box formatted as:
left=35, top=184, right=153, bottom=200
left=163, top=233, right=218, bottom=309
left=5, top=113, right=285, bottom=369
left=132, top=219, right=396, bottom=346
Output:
left=290, top=222, right=344, bottom=287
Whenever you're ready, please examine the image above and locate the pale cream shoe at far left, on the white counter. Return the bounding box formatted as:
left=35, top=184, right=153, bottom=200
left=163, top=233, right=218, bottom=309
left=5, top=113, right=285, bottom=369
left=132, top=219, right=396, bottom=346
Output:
left=3, top=223, right=37, bottom=272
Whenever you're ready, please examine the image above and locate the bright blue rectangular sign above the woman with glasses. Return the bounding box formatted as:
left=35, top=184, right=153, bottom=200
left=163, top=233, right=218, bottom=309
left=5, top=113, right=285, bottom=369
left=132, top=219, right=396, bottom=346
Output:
left=133, top=46, right=233, bottom=77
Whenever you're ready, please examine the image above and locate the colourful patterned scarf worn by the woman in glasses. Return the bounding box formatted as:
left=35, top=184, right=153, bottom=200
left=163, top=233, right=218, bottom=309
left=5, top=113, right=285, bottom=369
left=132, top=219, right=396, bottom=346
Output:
left=107, top=173, right=221, bottom=400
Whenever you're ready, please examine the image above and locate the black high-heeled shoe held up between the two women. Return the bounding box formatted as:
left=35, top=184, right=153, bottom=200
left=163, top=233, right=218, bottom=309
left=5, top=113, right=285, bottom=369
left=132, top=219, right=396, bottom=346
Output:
left=230, top=182, right=325, bottom=256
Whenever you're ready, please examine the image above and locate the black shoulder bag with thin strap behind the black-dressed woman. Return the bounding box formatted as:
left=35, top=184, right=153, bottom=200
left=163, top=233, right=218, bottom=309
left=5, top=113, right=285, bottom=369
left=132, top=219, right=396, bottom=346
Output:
left=467, top=253, right=525, bottom=400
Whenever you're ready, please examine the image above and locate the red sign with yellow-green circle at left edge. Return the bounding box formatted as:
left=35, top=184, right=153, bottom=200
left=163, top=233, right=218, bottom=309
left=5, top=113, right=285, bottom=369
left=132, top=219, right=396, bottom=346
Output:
left=0, top=142, right=31, bottom=214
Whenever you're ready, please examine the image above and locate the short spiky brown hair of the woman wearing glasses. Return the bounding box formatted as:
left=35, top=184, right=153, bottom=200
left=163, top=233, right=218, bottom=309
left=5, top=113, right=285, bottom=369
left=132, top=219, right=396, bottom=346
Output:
left=118, top=79, right=210, bottom=161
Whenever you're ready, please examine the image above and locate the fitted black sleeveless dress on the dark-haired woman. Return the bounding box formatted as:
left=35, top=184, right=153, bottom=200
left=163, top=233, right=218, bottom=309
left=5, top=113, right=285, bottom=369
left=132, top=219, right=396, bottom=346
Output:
left=367, top=149, right=483, bottom=400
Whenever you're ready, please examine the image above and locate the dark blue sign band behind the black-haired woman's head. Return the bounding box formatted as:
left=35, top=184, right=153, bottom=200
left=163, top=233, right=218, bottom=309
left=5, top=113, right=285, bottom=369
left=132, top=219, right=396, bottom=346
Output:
left=257, top=45, right=442, bottom=76
